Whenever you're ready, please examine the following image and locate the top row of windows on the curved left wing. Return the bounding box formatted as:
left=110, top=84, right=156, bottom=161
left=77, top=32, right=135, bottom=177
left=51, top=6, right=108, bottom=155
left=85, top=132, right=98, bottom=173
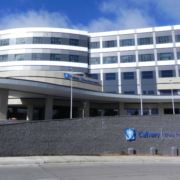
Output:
left=0, top=37, right=88, bottom=47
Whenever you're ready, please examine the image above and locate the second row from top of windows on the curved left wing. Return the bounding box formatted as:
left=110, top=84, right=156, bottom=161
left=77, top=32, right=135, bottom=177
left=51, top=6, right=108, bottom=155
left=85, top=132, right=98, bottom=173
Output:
left=0, top=53, right=87, bottom=63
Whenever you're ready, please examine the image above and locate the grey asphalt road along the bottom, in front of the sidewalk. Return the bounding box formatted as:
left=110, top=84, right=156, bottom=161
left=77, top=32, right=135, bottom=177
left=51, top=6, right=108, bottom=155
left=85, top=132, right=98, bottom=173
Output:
left=0, top=163, right=180, bottom=180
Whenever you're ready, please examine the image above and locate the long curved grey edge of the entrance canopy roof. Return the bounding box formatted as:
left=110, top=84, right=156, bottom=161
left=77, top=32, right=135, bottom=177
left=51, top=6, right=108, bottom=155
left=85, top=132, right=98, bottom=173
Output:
left=0, top=78, right=180, bottom=103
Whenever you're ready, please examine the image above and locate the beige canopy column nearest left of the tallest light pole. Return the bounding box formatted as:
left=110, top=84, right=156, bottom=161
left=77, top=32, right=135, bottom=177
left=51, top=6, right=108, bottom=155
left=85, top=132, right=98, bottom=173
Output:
left=45, top=95, right=53, bottom=120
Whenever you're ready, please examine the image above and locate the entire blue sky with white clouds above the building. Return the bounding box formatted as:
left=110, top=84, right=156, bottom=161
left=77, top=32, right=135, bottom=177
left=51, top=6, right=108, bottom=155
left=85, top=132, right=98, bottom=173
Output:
left=0, top=0, right=180, bottom=32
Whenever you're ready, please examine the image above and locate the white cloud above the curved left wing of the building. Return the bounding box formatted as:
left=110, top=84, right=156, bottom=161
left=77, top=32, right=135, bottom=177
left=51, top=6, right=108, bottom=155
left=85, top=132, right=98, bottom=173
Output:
left=0, top=11, right=70, bottom=30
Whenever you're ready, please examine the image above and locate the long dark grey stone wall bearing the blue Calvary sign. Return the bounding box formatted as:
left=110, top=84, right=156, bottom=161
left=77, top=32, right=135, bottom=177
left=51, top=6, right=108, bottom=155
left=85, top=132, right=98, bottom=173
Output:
left=0, top=115, right=180, bottom=155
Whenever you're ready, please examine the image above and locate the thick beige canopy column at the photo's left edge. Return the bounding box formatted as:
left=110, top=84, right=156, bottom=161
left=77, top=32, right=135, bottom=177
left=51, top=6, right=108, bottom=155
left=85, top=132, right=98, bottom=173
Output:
left=0, top=89, right=9, bottom=120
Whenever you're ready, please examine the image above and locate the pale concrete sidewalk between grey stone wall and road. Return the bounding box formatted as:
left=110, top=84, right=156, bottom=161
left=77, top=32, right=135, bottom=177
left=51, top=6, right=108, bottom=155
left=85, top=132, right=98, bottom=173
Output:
left=0, top=156, right=180, bottom=165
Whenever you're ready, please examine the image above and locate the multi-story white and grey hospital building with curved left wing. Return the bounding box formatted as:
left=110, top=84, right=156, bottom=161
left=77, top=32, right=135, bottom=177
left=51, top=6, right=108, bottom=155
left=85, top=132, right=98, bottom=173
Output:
left=0, top=25, right=180, bottom=120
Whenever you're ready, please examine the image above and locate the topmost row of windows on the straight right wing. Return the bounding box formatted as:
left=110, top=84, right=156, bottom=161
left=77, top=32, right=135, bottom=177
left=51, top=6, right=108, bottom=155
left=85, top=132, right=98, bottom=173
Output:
left=89, top=35, right=180, bottom=49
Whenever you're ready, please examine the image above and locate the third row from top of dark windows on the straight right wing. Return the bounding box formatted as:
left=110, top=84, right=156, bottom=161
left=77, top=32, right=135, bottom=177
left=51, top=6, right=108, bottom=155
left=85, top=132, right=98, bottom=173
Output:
left=88, top=70, right=174, bottom=81
